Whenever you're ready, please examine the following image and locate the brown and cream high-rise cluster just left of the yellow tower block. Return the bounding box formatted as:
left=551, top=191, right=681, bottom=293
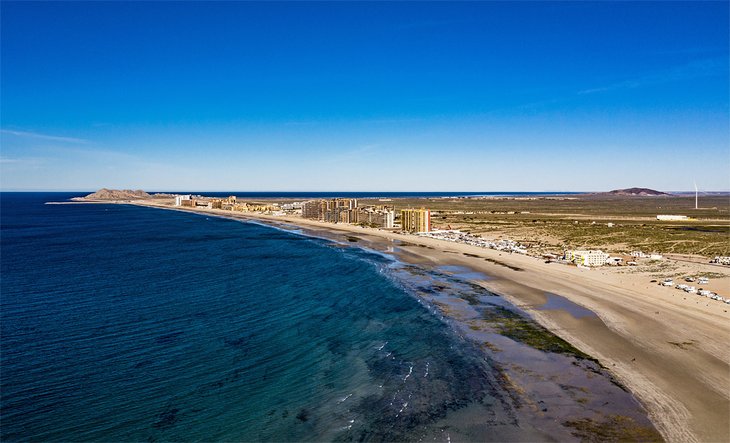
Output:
left=301, top=198, right=395, bottom=228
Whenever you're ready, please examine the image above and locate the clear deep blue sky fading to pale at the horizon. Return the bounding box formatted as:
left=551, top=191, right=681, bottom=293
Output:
left=0, top=1, right=730, bottom=191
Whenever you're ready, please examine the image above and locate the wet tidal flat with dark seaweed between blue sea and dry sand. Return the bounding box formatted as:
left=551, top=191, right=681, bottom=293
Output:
left=249, top=215, right=662, bottom=441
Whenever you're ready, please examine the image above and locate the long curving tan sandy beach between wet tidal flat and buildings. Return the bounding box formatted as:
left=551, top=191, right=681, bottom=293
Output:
left=128, top=201, right=730, bottom=442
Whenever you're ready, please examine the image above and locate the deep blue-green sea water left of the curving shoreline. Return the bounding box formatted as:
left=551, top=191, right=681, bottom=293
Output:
left=0, top=193, right=545, bottom=441
